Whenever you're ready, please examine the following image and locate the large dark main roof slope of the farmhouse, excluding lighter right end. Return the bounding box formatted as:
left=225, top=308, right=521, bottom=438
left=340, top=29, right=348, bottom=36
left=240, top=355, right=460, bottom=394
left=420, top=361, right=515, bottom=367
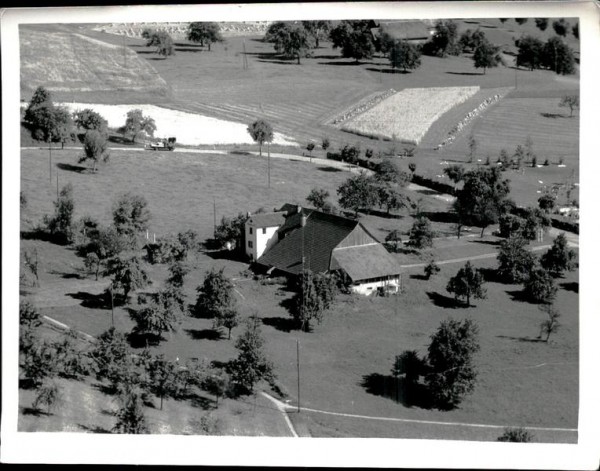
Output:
left=257, top=209, right=358, bottom=275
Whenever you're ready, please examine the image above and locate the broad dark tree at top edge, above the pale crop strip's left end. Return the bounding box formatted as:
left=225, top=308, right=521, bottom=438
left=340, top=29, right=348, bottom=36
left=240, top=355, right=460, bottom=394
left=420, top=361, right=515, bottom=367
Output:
left=329, top=20, right=375, bottom=63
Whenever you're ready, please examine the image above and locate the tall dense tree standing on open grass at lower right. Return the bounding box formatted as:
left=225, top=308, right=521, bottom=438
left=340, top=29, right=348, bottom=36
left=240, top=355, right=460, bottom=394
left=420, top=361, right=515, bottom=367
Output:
left=425, top=319, right=480, bottom=409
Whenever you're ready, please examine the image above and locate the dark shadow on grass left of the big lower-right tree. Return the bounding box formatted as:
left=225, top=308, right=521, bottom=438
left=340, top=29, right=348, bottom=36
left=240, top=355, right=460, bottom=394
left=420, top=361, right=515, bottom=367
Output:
left=360, top=373, right=433, bottom=409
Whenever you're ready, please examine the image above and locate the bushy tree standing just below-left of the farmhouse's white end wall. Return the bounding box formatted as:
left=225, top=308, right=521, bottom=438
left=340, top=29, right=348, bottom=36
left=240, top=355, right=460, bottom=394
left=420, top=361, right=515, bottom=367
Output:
left=193, top=268, right=235, bottom=319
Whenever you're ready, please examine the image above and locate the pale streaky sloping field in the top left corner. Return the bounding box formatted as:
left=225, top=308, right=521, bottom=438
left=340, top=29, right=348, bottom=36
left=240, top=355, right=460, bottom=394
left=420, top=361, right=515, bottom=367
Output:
left=20, top=27, right=169, bottom=101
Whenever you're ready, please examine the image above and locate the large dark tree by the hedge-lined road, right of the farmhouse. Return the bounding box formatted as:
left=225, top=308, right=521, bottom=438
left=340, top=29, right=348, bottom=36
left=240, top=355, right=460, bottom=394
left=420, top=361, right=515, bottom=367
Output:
left=454, top=167, right=510, bottom=237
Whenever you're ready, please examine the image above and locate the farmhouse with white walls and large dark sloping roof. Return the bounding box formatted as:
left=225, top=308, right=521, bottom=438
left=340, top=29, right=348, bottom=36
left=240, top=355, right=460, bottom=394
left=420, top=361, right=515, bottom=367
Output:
left=245, top=205, right=400, bottom=294
